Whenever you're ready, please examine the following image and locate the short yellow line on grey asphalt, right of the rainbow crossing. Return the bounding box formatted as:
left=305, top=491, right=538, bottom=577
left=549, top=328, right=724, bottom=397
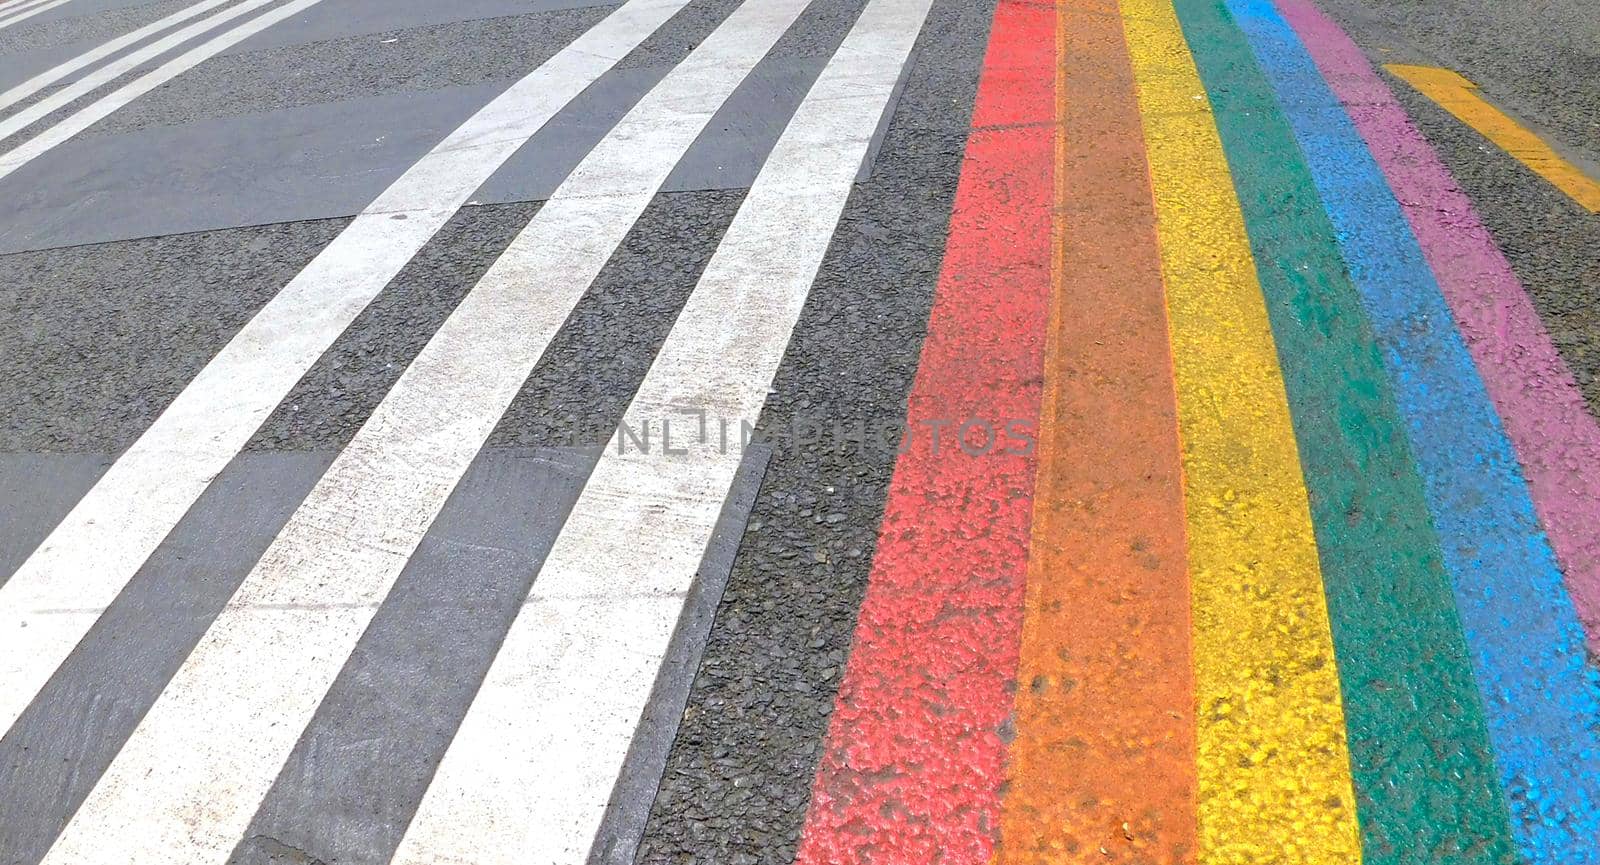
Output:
left=1384, top=64, right=1600, bottom=213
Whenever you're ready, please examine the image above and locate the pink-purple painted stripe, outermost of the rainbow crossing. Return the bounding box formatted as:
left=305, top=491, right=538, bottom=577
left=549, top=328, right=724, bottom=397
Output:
left=1277, top=0, right=1600, bottom=651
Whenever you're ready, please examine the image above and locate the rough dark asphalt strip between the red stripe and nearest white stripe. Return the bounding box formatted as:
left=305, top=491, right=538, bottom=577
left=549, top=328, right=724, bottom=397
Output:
left=637, top=0, right=994, bottom=865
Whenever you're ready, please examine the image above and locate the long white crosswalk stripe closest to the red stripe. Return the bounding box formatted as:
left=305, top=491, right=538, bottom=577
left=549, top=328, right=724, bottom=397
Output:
left=394, top=0, right=931, bottom=865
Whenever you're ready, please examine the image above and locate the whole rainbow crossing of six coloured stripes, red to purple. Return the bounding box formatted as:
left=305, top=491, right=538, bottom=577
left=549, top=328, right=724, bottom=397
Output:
left=800, top=0, right=1600, bottom=865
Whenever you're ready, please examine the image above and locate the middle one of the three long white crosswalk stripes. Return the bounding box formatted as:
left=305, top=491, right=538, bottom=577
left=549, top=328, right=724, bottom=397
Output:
left=45, top=0, right=808, bottom=865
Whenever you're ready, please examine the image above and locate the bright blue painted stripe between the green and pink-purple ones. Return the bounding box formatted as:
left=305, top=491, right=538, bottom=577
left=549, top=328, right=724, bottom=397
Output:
left=1226, top=0, right=1600, bottom=865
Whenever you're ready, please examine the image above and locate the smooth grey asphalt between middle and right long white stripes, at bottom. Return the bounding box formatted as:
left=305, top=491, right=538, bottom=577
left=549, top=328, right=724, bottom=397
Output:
left=229, top=448, right=601, bottom=865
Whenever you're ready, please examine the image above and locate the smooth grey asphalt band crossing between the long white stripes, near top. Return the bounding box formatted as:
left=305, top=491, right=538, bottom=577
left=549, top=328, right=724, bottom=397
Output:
left=0, top=58, right=866, bottom=254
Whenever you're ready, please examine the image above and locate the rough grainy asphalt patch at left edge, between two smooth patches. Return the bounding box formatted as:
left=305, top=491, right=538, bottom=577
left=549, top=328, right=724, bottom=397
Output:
left=0, top=219, right=347, bottom=454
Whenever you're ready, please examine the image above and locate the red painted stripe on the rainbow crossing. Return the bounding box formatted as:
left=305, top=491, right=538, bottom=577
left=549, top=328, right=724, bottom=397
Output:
left=798, top=0, right=1056, bottom=865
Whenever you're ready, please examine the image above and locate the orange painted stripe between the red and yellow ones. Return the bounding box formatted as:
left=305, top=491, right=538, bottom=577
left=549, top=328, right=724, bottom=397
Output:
left=997, top=0, right=1195, bottom=865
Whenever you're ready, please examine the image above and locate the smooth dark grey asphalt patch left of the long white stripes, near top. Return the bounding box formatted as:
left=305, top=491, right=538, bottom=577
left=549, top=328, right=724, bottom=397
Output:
left=0, top=85, right=501, bottom=254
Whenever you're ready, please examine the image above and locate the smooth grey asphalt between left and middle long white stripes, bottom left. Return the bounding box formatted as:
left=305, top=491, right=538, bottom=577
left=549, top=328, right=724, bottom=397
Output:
left=0, top=452, right=333, bottom=865
